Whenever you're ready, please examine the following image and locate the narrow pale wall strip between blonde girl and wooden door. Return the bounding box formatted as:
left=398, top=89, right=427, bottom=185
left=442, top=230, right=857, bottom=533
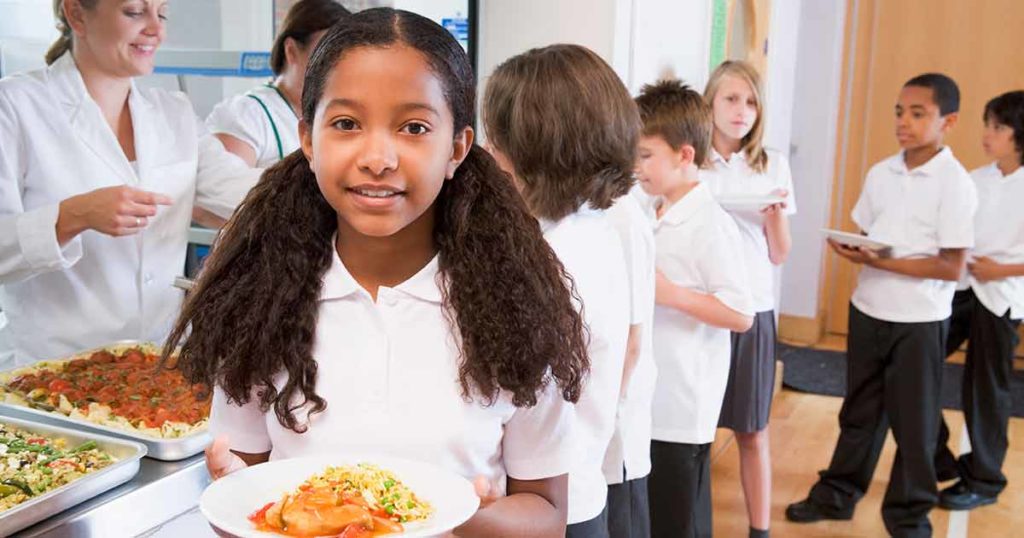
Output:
left=776, top=0, right=846, bottom=318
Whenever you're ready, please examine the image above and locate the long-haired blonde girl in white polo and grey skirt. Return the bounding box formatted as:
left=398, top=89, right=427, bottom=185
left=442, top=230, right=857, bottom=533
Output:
left=700, top=61, right=797, bottom=538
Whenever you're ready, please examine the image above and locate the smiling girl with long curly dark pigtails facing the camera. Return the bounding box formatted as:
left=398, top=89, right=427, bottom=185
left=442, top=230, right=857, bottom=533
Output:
left=165, top=8, right=588, bottom=537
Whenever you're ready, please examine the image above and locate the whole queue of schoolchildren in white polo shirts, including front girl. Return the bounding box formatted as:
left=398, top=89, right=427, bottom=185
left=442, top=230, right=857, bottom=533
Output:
left=167, top=8, right=1024, bottom=538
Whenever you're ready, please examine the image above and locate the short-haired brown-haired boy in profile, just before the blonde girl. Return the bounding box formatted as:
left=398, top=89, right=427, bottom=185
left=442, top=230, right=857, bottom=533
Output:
left=637, top=81, right=754, bottom=538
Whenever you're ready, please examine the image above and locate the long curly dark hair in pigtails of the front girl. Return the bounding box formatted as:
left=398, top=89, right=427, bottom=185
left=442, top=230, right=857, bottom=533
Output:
left=164, top=8, right=590, bottom=432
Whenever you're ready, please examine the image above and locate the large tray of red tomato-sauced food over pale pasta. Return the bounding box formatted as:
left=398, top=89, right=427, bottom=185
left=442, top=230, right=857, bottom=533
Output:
left=0, top=341, right=211, bottom=460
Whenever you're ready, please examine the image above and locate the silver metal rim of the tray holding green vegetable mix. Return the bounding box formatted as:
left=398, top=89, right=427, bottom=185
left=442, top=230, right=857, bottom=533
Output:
left=0, top=411, right=145, bottom=536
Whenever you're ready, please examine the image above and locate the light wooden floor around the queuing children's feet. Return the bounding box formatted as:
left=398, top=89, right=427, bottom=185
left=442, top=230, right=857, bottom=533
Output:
left=712, top=338, right=1024, bottom=538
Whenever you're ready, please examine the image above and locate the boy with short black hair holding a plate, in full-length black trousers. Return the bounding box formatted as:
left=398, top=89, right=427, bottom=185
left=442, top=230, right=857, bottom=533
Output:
left=785, top=74, right=977, bottom=537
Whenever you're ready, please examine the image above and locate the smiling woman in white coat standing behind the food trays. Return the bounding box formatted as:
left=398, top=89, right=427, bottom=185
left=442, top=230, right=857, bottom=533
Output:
left=0, top=0, right=260, bottom=365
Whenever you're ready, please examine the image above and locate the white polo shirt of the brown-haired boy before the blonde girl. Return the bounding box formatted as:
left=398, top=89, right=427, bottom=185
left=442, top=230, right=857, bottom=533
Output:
left=651, top=183, right=755, bottom=445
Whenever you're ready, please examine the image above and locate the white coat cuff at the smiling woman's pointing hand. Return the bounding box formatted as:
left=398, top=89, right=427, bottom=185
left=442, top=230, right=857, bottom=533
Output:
left=17, top=200, right=82, bottom=268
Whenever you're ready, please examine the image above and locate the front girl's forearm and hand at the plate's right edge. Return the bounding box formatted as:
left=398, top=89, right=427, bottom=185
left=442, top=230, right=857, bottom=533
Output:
left=453, top=474, right=569, bottom=538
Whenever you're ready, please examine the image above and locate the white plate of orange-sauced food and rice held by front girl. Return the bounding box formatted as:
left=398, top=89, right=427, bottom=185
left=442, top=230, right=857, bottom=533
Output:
left=199, top=455, right=479, bottom=538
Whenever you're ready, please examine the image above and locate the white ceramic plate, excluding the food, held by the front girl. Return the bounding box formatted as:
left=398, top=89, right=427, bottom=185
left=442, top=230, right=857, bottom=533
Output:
left=199, top=455, right=480, bottom=538
